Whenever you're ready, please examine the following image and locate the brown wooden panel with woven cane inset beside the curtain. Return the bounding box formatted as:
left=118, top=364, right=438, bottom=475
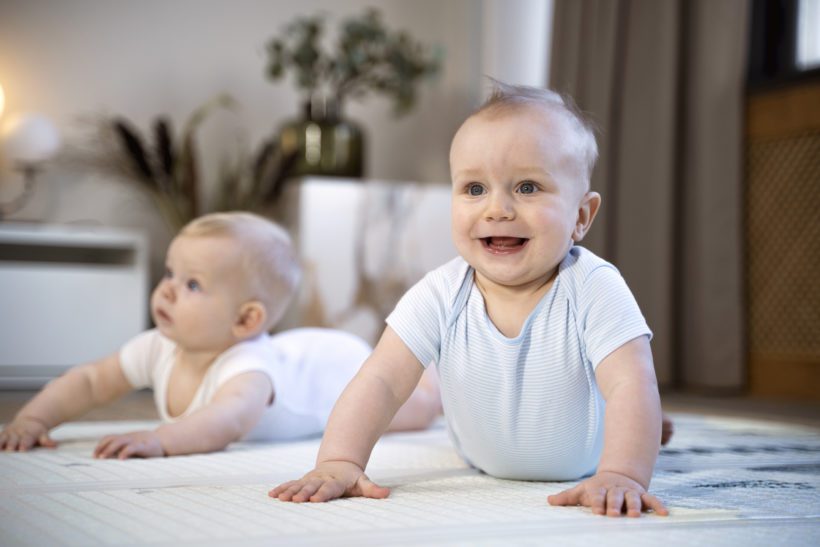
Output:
left=745, top=79, right=820, bottom=400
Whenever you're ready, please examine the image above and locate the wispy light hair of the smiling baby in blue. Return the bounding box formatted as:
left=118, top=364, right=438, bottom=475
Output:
left=473, top=78, right=598, bottom=188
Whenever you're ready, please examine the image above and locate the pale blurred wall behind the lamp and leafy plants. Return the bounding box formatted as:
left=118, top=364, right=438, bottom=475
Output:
left=0, top=0, right=551, bottom=292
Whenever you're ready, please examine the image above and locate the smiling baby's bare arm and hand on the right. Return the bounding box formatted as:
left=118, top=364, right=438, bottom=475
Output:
left=549, top=336, right=668, bottom=517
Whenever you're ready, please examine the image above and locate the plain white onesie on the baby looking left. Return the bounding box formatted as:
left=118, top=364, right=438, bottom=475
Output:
left=120, top=328, right=371, bottom=441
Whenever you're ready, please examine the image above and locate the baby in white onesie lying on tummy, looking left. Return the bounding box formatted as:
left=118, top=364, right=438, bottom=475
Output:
left=0, top=212, right=440, bottom=459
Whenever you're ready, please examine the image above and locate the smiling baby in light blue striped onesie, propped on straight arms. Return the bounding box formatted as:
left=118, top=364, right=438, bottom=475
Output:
left=270, top=82, right=667, bottom=517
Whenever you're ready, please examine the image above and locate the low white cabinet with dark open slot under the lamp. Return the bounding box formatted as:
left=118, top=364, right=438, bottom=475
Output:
left=0, top=223, right=148, bottom=388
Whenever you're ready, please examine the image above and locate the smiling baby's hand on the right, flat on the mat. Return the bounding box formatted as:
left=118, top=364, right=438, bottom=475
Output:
left=547, top=471, right=669, bottom=517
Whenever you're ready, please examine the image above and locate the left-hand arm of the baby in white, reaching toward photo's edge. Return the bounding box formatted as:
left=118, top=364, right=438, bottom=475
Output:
left=0, top=353, right=133, bottom=452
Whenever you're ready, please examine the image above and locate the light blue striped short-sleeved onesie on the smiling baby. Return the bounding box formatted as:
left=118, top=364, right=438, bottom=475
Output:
left=387, top=246, right=652, bottom=481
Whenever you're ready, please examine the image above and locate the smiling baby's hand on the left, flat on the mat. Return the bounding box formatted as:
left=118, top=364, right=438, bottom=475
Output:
left=268, top=461, right=390, bottom=503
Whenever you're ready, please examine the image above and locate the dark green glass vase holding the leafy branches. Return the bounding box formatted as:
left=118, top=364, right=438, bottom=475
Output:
left=279, top=96, right=365, bottom=178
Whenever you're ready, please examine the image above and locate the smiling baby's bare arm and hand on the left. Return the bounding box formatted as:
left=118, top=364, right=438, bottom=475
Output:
left=269, top=326, right=424, bottom=502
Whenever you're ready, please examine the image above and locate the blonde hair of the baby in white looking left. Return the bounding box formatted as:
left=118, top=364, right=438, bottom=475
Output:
left=179, top=211, right=301, bottom=330
